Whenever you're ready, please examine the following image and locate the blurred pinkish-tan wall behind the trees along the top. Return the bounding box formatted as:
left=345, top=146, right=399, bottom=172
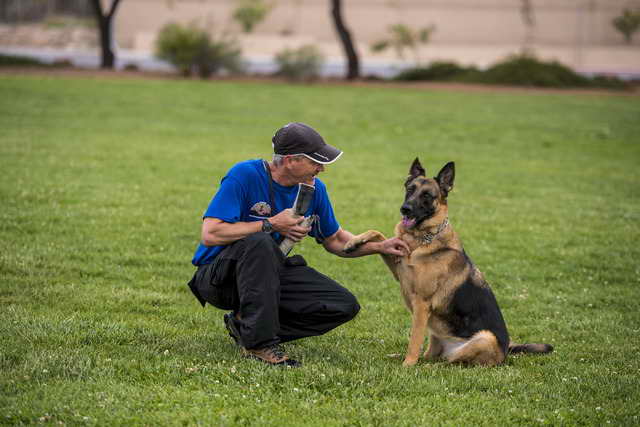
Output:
left=118, top=0, right=640, bottom=45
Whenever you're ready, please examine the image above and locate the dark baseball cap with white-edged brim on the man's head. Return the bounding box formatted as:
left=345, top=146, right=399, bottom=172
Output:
left=271, top=122, right=342, bottom=165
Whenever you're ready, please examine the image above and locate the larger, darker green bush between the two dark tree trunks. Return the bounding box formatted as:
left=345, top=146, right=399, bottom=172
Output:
left=156, top=23, right=241, bottom=78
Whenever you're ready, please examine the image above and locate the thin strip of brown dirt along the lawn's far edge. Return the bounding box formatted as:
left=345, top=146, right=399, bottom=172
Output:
left=0, top=67, right=640, bottom=96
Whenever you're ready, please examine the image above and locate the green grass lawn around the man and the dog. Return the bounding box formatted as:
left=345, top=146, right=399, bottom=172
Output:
left=0, top=75, right=640, bottom=426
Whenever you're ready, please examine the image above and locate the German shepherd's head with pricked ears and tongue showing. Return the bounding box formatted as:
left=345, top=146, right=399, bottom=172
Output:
left=400, top=157, right=455, bottom=229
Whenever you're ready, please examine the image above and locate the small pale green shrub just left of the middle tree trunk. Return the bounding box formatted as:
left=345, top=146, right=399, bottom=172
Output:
left=275, top=45, right=324, bottom=81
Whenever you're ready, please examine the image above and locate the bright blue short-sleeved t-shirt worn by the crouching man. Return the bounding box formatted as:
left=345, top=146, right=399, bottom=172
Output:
left=191, top=159, right=340, bottom=266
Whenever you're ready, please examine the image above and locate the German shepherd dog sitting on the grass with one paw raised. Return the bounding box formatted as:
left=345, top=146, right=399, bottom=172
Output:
left=344, top=158, right=553, bottom=366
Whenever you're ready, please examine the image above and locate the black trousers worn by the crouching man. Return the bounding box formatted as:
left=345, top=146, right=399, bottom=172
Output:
left=190, top=233, right=360, bottom=348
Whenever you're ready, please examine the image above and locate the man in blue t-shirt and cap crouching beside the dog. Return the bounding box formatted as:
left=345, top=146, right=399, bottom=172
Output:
left=189, top=123, right=409, bottom=367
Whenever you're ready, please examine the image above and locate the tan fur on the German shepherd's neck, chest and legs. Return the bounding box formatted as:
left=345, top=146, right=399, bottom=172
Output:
left=345, top=177, right=506, bottom=366
